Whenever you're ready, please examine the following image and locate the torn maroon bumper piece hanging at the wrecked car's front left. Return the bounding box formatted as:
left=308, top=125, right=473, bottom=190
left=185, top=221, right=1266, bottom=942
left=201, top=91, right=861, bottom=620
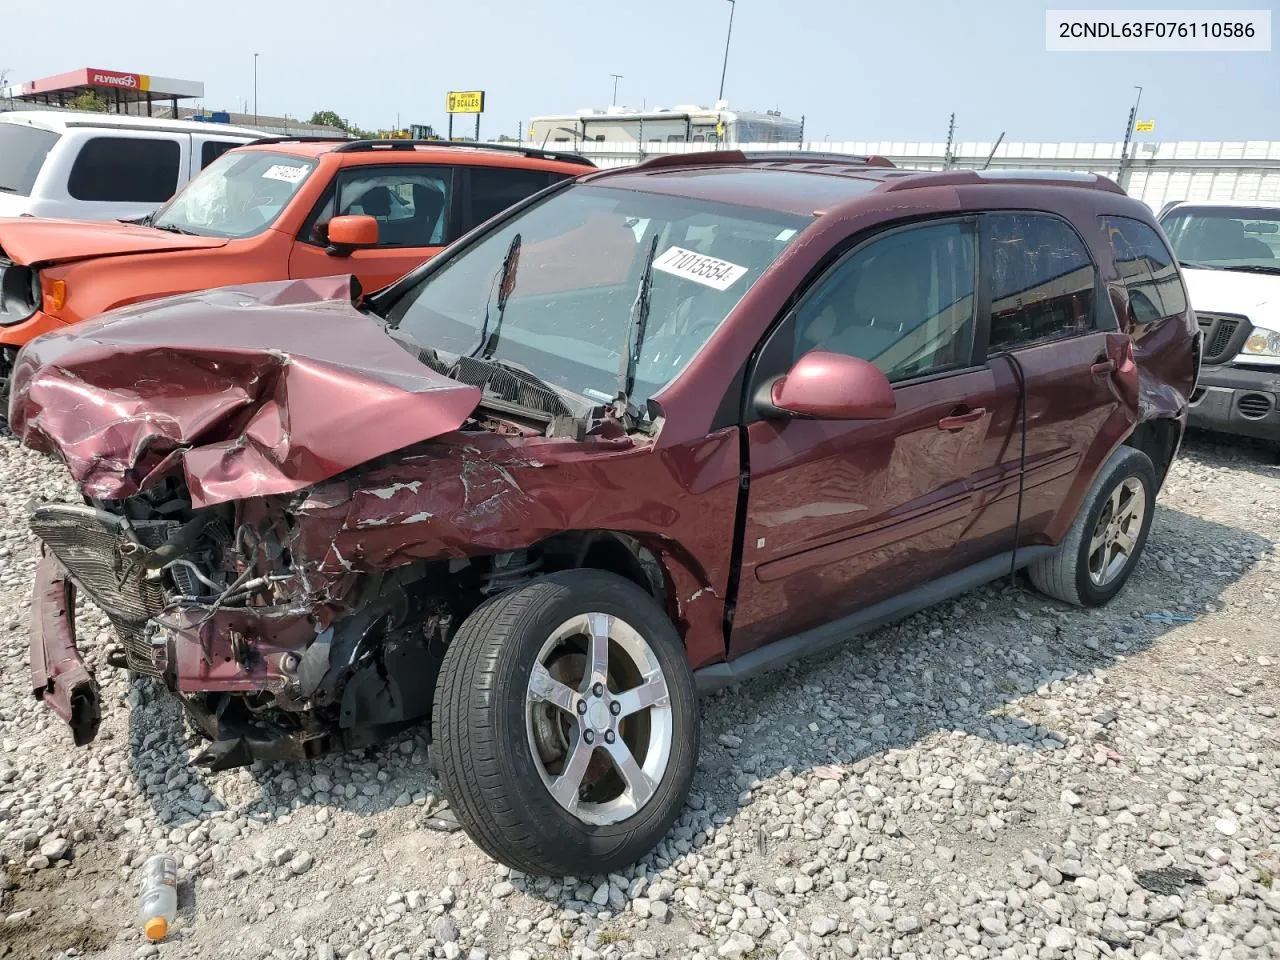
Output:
left=29, top=557, right=102, bottom=746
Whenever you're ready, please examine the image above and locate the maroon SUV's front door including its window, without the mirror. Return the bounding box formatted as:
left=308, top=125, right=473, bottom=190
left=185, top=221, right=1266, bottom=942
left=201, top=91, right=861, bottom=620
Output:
left=730, top=220, right=1007, bottom=658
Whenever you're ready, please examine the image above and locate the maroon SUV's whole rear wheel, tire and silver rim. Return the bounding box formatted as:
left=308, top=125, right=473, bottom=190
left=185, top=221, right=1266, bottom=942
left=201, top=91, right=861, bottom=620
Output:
left=1027, top=447, right=1157, bottom=607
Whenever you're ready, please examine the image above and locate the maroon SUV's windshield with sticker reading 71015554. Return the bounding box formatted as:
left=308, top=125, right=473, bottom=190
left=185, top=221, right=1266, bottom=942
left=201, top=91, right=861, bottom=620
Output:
left=388, top=186, right=812, bottom=406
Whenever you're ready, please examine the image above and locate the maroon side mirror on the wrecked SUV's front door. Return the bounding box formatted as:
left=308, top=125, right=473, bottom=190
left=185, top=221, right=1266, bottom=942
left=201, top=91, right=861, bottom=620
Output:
left=756, top=349, right=897, bottom=420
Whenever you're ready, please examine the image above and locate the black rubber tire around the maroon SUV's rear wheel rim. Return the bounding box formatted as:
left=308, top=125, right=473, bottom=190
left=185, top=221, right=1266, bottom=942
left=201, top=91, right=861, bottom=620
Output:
left=1027, top=447, right=1158, bottom=607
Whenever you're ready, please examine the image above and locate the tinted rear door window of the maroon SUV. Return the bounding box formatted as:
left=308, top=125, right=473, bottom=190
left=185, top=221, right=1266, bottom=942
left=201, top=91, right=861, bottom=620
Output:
left=983, top=214, right=1096, bottom=351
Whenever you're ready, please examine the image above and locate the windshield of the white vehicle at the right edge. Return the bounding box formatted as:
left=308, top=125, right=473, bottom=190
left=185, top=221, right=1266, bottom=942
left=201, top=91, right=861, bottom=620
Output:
left=1160, top=206, right=1280, bottom=273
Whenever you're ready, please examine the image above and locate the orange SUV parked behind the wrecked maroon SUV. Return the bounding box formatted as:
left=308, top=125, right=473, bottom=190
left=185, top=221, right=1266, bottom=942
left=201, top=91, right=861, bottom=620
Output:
left=0, top=138, right=594, bottom=408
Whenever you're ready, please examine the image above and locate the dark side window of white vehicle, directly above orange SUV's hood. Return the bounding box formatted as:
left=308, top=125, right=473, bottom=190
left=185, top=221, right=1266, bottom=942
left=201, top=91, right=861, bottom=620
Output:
left=67, top=137, right=180, bottom=204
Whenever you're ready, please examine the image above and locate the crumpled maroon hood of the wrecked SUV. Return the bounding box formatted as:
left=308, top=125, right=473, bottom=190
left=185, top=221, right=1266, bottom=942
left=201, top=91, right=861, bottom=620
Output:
left=9, top=276, right=480, bottom=507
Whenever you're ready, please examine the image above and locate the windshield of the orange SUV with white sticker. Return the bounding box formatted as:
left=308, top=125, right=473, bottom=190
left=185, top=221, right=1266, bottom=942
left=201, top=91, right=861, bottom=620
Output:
left=151, top=150, right=315, bottom=239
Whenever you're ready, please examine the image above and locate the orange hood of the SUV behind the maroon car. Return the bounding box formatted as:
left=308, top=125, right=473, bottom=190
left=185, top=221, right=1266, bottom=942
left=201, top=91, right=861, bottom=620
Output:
left=0, top=216, right=227, bottom=266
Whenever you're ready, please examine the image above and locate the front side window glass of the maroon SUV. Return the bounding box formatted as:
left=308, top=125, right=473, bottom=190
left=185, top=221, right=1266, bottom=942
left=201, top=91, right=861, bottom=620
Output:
left=792, top=221, right=977, bottom=381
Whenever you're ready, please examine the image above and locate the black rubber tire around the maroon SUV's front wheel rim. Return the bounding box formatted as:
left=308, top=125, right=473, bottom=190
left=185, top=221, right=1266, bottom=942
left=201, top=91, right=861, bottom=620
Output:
left=431, top=570, right=699, bottom=877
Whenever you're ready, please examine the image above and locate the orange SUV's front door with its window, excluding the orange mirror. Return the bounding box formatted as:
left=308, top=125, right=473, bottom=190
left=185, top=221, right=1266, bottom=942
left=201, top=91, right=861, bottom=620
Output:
left=289, top=164, right=457, bottom=291
